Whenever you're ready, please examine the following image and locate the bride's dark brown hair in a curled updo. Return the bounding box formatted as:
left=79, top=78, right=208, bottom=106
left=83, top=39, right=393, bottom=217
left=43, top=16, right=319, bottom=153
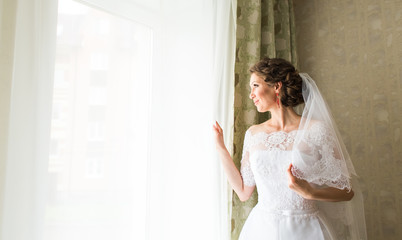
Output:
left=249, top=57, right=304, bottom=107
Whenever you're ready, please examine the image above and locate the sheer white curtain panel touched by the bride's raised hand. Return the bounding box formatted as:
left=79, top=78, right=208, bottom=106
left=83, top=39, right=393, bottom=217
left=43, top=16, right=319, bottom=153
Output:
left=150, top=1, right=235, bottom=239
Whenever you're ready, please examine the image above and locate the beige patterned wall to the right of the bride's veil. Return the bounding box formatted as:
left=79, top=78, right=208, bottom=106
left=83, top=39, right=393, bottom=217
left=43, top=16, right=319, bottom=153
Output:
left=294, top=0, right=402, bottom=240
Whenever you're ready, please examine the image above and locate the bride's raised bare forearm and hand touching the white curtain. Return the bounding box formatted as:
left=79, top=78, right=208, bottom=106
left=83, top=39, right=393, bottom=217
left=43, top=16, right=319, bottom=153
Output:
left=213, top=123, right=255, bottom=201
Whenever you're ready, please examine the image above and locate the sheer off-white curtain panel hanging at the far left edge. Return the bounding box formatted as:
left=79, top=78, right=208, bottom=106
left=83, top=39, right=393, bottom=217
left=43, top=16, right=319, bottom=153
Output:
left=1, top=0, right=57, bottom=239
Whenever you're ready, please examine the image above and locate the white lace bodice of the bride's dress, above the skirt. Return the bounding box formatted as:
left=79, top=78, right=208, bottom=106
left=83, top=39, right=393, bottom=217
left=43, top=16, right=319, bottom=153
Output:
left=241, top=130, right=315, bottom=210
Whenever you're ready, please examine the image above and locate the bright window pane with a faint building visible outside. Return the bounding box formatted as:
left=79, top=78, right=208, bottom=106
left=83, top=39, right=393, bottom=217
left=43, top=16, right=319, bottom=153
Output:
left=44, top=0, right=152, bottom=240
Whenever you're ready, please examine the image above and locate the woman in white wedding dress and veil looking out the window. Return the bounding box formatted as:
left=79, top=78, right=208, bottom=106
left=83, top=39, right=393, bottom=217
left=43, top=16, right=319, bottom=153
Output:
left=214, top=58, right=366, bottom=240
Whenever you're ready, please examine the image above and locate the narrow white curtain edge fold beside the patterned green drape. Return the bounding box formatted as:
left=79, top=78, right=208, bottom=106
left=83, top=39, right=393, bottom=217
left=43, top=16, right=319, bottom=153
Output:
left=213, top=0, right=236, bottom=240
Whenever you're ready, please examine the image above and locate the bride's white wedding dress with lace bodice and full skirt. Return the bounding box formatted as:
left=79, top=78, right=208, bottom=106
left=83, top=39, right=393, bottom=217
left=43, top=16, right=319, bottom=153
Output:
left=239, top=123, right=335, bottom=240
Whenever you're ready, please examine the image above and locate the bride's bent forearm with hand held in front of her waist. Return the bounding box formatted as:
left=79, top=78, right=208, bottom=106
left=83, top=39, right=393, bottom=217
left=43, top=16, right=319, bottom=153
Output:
left=287, top=164, right=354, bottom=202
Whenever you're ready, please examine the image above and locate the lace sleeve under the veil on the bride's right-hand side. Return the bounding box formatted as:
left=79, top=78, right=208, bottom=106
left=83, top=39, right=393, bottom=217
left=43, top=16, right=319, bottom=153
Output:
left=293, top=123, right=351, bottom=190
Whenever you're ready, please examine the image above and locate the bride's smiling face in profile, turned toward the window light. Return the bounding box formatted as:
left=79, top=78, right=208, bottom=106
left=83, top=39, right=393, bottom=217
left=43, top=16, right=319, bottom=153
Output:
left=249, top=73, right=277, bottom=112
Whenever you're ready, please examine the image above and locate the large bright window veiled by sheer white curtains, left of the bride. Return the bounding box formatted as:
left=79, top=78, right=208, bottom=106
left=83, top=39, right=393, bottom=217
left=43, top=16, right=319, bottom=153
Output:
left=1, top=0, right=231, bottom=240
